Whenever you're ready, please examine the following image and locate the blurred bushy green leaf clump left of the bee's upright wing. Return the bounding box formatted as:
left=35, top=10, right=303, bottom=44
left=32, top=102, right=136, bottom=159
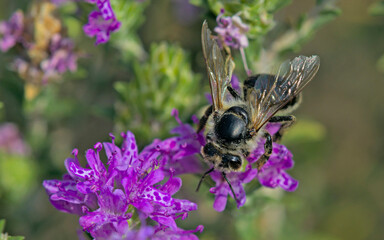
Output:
left=114, top=43, right=203, bottom=144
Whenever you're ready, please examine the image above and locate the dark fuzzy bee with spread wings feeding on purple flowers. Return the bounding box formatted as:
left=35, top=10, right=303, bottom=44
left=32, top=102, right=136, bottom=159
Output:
left=196, top=21, right=320, bottom=199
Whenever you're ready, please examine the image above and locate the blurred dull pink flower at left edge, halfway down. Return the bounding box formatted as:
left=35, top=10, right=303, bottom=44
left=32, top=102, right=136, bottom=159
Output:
left=0, top=123, right=30, bottom=155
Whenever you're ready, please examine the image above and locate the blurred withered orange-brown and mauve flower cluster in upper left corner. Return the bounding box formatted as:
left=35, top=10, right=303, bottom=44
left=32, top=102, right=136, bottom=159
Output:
left=0, top=2, right=78, bottom=99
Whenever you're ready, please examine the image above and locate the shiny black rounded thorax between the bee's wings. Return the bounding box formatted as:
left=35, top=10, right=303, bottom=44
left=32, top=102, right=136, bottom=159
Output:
left=215, top=106, right=248, bottom=142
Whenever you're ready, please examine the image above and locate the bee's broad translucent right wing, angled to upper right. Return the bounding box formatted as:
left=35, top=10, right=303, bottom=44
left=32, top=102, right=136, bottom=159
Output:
left=249, top=55, right=320, bottom=131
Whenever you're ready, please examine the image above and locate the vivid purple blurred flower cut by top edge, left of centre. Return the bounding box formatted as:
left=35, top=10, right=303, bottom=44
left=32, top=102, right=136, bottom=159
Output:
left=83, top=0, right=121, bottom=45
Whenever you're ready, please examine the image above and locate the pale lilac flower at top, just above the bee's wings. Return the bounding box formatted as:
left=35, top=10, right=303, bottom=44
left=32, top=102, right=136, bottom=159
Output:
left=215, top=9, right=249, bottom=49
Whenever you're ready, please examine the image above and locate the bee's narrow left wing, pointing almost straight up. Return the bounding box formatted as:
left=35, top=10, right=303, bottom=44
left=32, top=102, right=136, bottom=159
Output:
left=201, top=21, right=235, bottom=111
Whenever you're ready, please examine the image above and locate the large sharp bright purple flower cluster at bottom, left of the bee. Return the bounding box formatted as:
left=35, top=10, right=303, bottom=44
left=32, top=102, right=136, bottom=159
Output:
left=43, top=127, right=202, bottom=239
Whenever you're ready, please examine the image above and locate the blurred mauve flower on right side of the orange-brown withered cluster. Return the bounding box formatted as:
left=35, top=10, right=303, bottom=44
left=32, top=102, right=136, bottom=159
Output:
left=41, top=34, right=78, bottom=82
